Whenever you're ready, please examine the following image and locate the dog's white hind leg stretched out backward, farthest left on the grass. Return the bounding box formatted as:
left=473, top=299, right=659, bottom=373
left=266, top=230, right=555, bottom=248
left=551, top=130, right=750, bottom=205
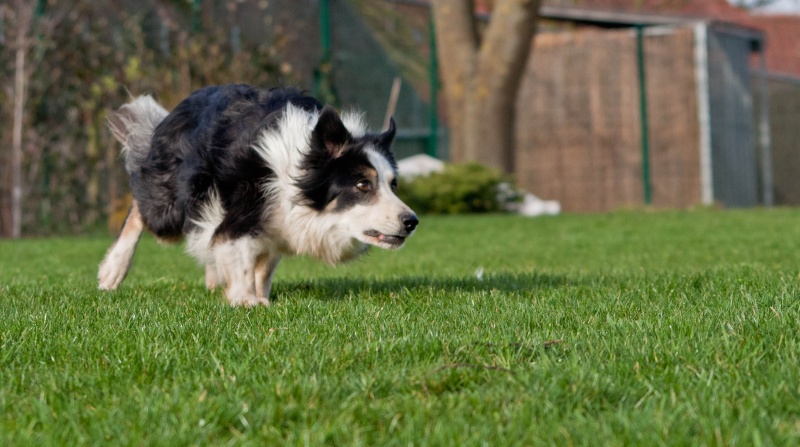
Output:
left=97, top=200, right=144, bottom=290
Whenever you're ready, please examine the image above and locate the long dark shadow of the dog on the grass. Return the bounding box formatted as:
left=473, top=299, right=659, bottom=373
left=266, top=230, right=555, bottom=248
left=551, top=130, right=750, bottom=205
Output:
left=272, top=273, right=575, bottom=300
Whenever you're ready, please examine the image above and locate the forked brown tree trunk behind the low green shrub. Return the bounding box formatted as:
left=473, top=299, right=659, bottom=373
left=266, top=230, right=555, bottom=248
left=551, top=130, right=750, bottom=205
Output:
left=433, top=0, right=541, bottom=173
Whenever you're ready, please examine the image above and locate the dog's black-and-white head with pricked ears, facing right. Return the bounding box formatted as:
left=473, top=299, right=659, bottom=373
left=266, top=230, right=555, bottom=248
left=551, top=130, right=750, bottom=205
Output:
left=297, top=106, right=419, bottom=249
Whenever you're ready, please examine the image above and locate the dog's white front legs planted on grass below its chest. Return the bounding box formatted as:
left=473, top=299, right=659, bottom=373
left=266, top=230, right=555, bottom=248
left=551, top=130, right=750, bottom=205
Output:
left=213, top=237, right=269, bottom=307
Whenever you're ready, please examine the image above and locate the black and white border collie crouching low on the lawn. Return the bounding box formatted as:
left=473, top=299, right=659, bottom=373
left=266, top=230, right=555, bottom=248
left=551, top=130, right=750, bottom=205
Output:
left=98, top=85, right=418, bottom=306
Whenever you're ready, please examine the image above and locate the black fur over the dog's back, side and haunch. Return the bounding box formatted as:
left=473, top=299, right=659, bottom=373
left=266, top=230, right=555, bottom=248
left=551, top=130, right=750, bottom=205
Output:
left=136, top=85, right=322, bottom=243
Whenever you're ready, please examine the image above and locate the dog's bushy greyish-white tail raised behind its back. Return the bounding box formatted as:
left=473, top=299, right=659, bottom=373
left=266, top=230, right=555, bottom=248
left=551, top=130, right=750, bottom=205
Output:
left=108, top=95, right=169, bottom=174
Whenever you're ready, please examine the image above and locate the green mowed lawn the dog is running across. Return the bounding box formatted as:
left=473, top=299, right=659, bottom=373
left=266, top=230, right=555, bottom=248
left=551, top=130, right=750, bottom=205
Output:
left=0, top=209, right=800, bottom=446
